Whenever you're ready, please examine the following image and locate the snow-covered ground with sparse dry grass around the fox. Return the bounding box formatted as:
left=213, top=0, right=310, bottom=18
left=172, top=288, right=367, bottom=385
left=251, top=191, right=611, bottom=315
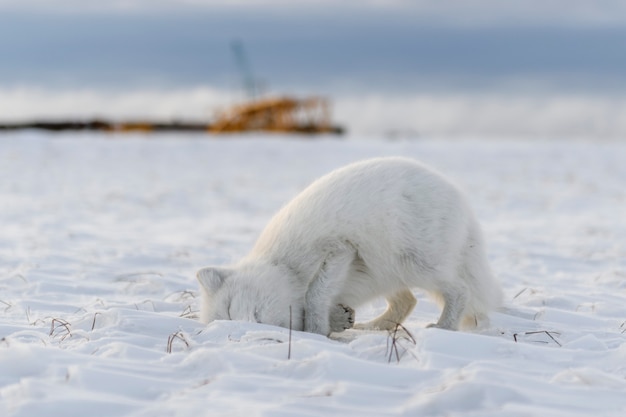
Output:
left=0, top=132, right=626, bottom=417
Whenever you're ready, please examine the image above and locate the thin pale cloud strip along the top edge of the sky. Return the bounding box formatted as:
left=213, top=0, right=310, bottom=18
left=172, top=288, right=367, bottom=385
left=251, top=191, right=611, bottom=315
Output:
left=0, top=0, right=626, bottom=26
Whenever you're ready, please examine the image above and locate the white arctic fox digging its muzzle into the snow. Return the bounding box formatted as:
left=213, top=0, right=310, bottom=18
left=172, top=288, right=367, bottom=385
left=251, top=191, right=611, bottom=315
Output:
left=197, top=157, right=501, bottom=335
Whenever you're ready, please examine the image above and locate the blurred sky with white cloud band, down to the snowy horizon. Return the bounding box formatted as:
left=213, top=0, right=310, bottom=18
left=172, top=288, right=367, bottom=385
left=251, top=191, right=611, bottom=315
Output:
left=0, top=0, right=626, bottom=140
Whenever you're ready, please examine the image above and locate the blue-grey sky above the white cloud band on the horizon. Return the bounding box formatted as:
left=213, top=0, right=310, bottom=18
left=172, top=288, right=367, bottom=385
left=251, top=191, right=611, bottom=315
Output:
left=0, top=0, right=626, bottom=94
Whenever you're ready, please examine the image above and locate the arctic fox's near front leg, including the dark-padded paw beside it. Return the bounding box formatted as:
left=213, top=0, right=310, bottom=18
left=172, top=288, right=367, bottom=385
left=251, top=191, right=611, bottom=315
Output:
left=304, top=247, right=355, bottom=336
